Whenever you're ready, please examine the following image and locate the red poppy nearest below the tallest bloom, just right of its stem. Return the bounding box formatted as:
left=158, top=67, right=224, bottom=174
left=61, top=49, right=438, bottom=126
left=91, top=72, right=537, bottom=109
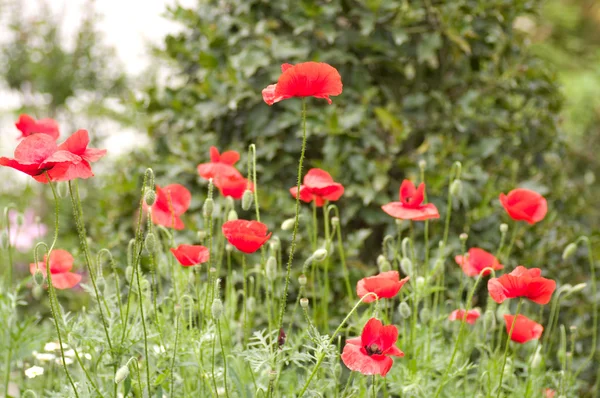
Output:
left=290, top=169, right=344, bottom=207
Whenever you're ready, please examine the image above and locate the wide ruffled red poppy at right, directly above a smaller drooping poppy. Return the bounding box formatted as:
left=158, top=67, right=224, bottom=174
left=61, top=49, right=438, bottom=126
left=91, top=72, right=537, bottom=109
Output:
left=488, top=265, right=556, bottom=304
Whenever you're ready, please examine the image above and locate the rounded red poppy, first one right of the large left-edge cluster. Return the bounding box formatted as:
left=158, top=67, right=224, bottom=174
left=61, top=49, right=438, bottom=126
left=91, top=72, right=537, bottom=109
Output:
left=152, top=184, right=192, bottom=230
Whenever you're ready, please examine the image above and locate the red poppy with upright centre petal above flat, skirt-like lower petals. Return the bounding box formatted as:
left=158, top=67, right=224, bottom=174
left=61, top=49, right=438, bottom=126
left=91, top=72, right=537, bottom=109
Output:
left=381, top=180, right=440, bottom=221
